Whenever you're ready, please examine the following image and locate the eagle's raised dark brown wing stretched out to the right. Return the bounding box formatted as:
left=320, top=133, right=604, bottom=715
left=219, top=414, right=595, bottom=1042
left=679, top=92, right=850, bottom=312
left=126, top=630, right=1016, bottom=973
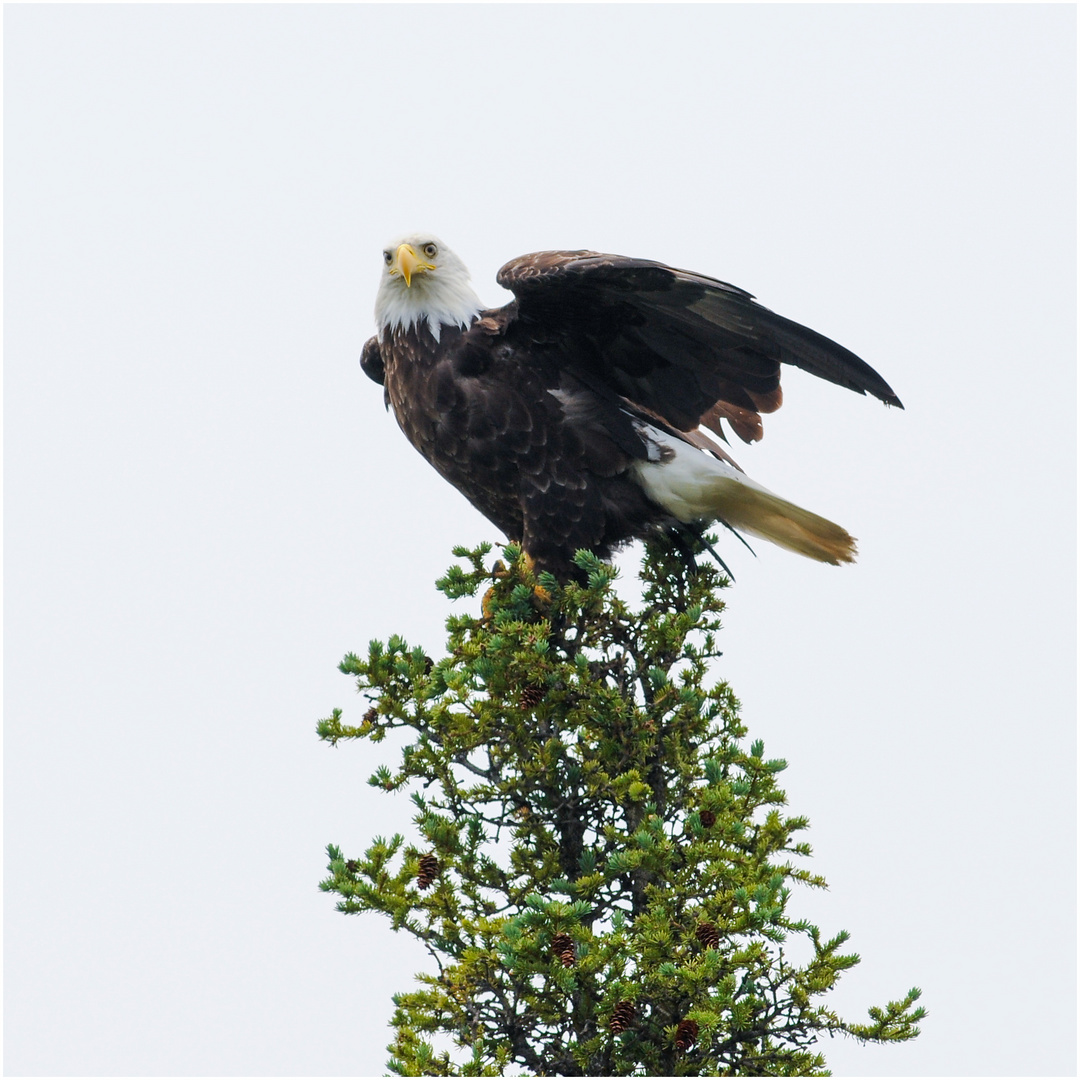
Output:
left=498, top=251, right=903, bottom=442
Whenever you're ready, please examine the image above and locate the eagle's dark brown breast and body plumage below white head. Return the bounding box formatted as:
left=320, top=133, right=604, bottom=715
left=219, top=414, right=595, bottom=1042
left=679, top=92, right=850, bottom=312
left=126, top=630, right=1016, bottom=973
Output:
left=367, top=312, right=670, bottom=576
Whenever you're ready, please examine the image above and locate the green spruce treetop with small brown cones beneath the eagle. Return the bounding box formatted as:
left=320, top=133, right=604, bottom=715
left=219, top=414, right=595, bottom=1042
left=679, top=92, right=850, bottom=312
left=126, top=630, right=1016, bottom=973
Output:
left=318, top=542, right=924, bottom=1076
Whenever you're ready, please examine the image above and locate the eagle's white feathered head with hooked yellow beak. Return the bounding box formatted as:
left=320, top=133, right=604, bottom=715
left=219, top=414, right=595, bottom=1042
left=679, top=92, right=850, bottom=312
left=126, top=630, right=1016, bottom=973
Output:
left=375, top=232, right=484, bottom=341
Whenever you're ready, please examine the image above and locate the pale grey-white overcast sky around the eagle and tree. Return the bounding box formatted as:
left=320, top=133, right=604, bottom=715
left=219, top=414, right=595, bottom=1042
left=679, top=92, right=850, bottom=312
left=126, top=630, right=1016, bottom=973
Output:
left=4, top=4, right=1076, bottom=1075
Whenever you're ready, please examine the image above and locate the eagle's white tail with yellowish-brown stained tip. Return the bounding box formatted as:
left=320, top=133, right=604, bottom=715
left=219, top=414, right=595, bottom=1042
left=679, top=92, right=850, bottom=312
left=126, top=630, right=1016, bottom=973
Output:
left=634, top=426, right=855, bottom=566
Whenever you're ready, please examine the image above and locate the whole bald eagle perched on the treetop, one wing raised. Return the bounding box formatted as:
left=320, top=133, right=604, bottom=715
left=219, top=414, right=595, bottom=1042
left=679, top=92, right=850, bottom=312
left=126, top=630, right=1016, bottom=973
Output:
left=361, top=233, right=903, bottom=580
